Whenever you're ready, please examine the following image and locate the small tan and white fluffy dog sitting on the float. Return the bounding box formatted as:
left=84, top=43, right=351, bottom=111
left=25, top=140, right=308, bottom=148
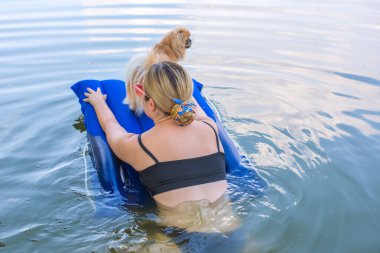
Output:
left=124, top=27, right=191, bottom=115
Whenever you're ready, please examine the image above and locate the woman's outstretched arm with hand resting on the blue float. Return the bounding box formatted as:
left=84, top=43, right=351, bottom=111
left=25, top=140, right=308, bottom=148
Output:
left=83, top=88, right=135, bottom=162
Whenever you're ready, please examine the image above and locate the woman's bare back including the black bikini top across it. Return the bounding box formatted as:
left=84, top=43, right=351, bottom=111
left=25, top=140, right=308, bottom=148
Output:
left=132, top=120, right=227, bottom=207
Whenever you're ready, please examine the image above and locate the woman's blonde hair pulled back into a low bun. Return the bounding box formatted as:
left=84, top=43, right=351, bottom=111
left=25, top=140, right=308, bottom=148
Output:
left=143, top=62, right=195, bottom=125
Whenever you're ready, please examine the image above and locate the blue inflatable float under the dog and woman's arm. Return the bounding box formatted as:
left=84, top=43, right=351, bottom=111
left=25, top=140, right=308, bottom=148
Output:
left=71, top=80, right=268, bottom=205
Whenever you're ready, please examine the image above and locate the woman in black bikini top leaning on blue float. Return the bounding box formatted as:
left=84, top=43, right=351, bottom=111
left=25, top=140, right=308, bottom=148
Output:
left=84, top=62, right=242, bottom=251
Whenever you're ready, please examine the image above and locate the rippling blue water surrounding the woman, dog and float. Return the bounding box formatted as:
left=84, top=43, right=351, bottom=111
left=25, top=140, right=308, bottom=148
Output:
left=0, top=0, right=380, bottom=253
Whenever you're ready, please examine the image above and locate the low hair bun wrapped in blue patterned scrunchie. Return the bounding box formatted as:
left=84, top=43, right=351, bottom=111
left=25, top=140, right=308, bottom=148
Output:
left=170, top=98, right=195, bottom=126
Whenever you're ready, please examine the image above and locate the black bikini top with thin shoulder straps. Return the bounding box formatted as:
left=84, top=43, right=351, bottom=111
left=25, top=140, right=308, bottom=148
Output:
left=138, top=121, right=226, bottom=196
